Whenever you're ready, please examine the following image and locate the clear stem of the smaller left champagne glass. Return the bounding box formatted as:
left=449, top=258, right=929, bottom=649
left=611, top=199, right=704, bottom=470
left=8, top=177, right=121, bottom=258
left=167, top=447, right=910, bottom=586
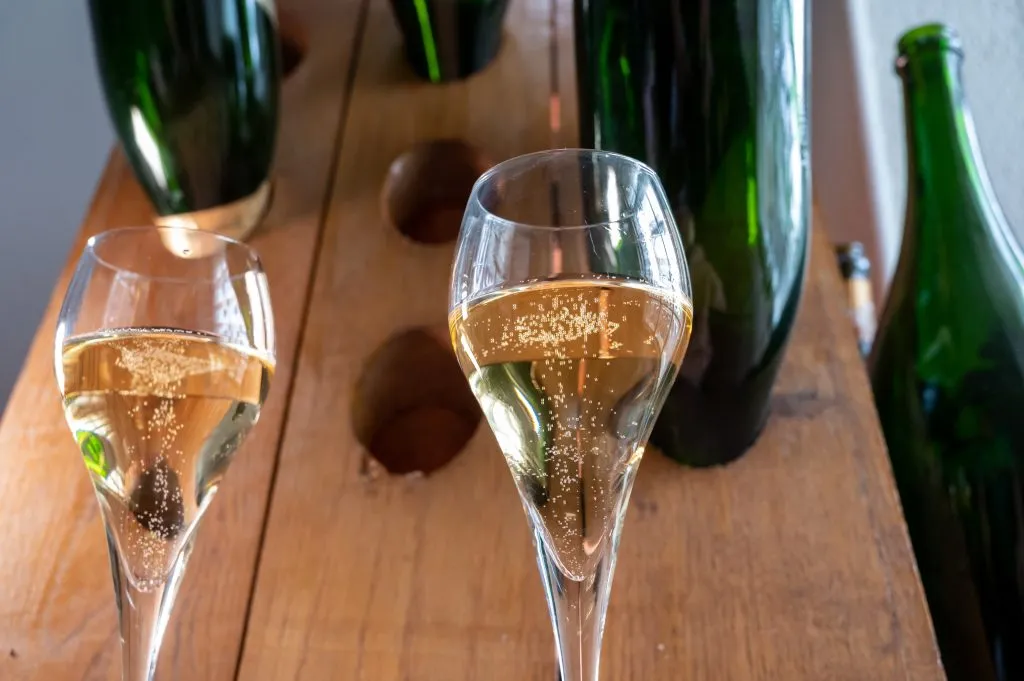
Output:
left=106, top=522, right=195, bottom=681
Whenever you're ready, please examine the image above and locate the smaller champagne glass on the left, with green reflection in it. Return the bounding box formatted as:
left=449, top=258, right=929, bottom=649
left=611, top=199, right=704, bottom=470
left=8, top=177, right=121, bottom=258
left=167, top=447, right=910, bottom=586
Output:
left=54, top=227, right=274, bottom=681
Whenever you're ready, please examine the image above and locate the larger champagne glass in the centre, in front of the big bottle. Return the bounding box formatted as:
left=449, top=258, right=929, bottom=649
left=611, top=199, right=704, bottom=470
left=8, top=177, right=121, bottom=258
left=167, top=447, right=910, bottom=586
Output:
left=449, top=150, right=692, bottom=681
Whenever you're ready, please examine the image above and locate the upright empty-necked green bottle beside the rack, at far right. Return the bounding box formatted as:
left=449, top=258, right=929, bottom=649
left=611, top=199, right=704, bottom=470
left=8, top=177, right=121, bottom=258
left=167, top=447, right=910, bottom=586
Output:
left=870, top=25, right=1024, bottom=681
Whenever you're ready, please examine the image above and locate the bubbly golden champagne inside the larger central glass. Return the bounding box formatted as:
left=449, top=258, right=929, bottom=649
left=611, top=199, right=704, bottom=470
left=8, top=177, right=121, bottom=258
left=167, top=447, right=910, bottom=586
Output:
left=452, top=278, right=688, bottom=580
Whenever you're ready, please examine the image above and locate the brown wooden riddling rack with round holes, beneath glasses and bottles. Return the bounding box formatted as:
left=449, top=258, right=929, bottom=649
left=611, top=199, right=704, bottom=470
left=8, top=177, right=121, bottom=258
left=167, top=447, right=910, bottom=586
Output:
left=0, top=0, right=943, bottom=681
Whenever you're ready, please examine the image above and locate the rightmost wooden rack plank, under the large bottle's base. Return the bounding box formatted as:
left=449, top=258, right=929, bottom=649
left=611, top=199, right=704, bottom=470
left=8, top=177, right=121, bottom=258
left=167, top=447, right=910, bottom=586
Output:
left=556, top=0, right=945, bottom=681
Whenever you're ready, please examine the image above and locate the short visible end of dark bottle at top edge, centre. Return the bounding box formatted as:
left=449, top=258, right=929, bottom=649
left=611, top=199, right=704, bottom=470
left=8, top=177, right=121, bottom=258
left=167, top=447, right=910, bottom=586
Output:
left=391, top=0, right=509, bottom=83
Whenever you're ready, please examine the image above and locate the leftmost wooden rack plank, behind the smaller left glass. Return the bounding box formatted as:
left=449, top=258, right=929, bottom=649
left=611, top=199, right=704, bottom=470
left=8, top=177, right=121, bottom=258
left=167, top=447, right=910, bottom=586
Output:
left=0, top=0, right=362, bottom=681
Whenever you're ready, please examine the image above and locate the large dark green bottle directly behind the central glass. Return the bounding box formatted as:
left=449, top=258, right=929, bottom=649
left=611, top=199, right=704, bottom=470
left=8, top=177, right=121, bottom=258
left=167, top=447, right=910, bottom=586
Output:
left=574, top=0, right=811, bottom=466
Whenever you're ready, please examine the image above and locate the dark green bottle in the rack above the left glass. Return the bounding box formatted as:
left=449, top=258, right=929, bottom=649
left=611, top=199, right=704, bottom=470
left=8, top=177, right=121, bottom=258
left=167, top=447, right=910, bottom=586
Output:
left=89, top=0, right=281, bottom=236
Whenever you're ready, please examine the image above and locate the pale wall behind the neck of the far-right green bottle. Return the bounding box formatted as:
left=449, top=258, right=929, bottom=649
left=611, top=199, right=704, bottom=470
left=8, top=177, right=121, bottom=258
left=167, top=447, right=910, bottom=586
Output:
left=813, top=0, right=1024, bottom=297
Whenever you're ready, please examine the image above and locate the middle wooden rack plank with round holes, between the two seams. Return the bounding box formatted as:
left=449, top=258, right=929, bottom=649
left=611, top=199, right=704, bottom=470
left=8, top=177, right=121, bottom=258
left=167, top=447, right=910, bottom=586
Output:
left=239, top=0, right=553, bottom=681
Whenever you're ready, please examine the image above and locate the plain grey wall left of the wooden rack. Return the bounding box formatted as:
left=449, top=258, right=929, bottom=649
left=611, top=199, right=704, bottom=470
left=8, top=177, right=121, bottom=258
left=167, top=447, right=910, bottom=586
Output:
left=0, top=0, right=114, bottom=407
